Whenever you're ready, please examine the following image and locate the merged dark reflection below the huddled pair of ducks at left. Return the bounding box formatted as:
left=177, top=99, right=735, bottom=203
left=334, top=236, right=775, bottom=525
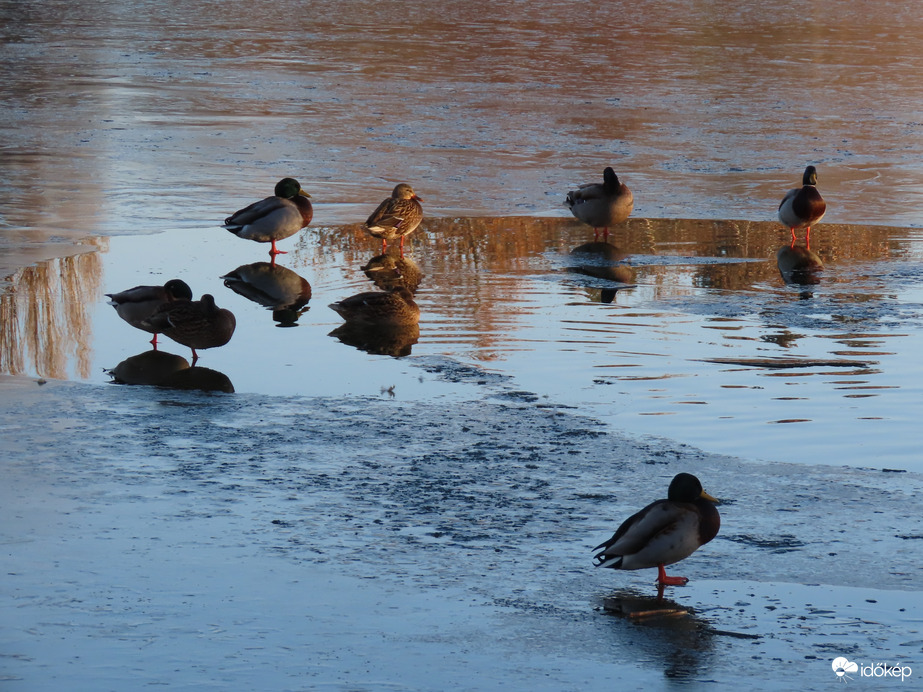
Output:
left=108, top=350, right=234, bottom=394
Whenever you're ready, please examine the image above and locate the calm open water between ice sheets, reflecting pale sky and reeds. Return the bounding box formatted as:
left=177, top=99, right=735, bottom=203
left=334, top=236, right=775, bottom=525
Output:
left=0, top=218, right=923, bottom=471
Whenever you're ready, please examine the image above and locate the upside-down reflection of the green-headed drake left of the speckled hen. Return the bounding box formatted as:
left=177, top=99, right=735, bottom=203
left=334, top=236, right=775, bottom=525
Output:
left=221, top=262, right=311, bottom=327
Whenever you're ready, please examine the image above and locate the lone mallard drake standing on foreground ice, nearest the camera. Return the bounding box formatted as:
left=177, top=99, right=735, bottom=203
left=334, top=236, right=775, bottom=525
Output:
left=593, top=473, right=721, bottom=586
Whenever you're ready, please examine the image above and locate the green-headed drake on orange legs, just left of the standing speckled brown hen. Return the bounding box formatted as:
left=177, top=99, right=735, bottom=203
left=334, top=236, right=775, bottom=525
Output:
left=222, top=178, right=314, bottom=260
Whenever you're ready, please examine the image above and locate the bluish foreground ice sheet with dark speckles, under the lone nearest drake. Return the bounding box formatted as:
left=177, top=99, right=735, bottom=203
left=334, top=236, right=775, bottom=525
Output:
left=0, top=361, right=923, bottom=690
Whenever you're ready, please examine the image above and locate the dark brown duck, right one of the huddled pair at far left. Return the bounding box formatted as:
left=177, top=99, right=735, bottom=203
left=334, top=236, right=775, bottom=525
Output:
left=147, top=293, right=237, bottom=365
